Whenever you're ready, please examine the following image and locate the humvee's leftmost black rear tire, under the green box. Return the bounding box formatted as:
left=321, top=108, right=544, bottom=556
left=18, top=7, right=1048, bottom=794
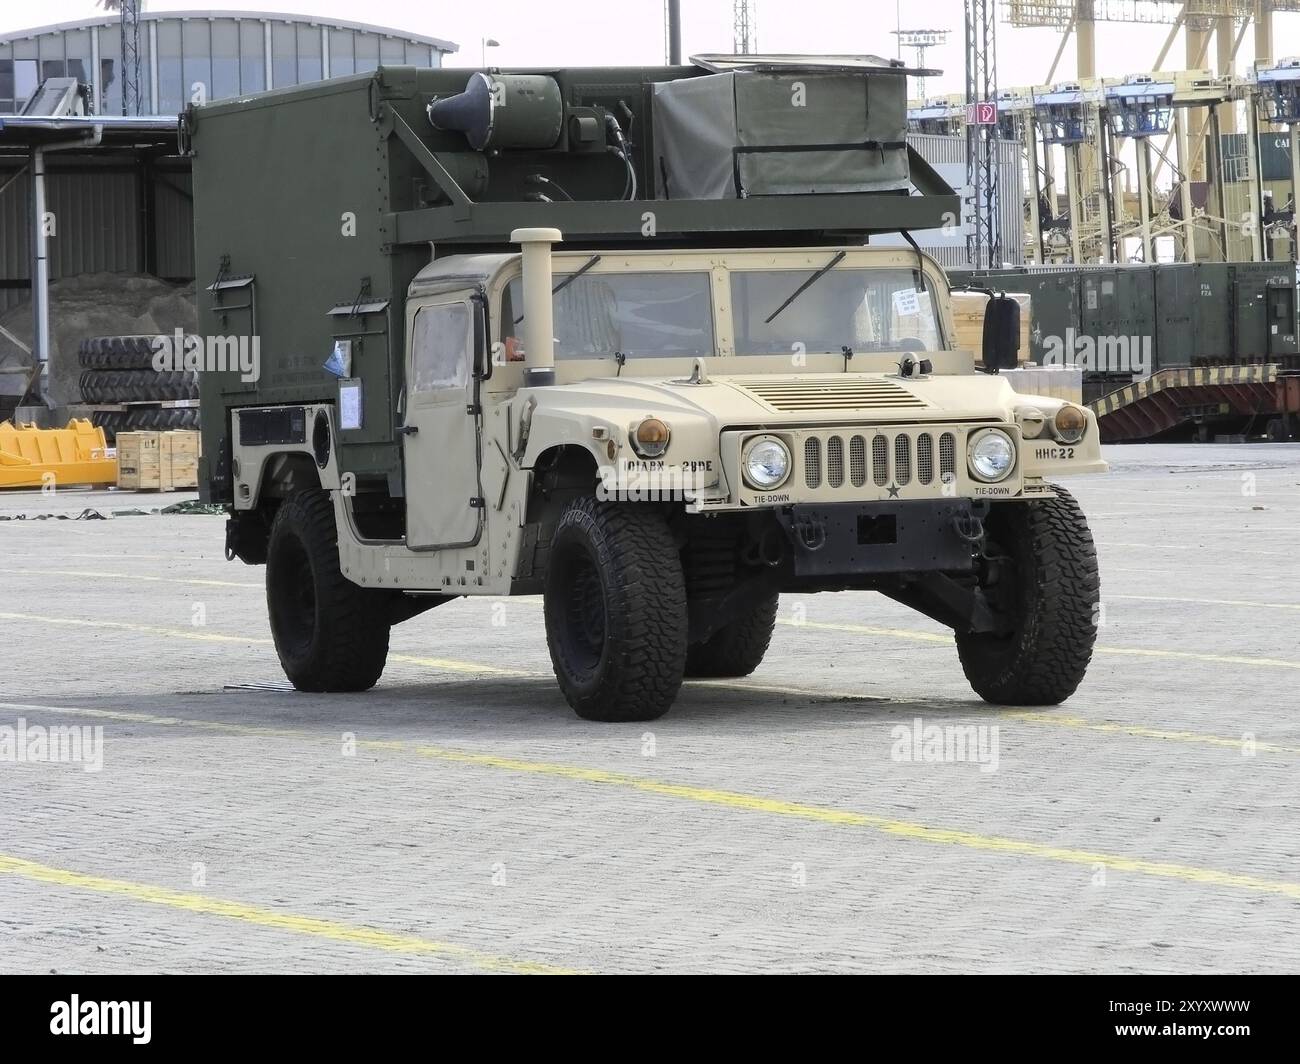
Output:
left=267, top=490, right=391, bottom=691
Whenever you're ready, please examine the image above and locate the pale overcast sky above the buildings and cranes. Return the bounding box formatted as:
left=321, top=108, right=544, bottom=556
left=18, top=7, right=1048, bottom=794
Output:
left=0, top=0, right=1300, bottom=95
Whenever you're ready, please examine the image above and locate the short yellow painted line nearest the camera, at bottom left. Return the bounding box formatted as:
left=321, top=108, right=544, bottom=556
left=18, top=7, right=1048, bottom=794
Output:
left=0, top=853, right=576, bottom=976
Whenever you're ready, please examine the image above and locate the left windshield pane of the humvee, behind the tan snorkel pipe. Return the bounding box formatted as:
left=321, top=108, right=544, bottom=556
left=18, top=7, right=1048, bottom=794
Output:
left=501, top=271, right=715, bottom=359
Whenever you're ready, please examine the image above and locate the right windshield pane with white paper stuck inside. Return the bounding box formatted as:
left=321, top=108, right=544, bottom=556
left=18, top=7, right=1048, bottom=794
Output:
left=731, top=267, right=943, bottom=355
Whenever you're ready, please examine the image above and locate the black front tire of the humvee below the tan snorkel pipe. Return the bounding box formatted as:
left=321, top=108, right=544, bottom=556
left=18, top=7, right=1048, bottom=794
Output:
left=545, top=498, right=686, bottom=722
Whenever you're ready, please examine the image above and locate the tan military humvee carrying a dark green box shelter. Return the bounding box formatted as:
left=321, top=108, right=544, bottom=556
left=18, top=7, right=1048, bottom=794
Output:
left=182, top=56, right=1105, bottom=721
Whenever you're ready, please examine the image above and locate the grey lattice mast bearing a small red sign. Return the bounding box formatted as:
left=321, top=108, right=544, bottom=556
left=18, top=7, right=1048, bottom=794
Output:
left=966, top=0, right=1002, bottom=268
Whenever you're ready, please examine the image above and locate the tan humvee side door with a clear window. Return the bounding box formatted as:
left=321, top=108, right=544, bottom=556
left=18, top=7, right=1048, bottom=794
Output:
left=400, top=293, right=484, bottom=550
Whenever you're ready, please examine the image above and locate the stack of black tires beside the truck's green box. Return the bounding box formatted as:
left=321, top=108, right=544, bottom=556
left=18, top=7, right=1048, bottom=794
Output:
left=77, top=333, right=199, bottom=444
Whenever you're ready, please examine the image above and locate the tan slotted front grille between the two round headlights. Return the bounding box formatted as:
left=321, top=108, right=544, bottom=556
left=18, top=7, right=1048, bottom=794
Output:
left=803, top=429, right=972, bottom=490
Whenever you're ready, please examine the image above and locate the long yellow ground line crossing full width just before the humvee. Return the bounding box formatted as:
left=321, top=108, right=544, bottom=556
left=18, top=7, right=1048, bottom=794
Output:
left=0, top=704, right=1300, bottom=901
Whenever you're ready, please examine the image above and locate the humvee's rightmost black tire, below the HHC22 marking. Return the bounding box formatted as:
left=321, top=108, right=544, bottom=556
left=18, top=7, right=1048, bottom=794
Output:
left=957, top=485, right=1101, bottom=705
